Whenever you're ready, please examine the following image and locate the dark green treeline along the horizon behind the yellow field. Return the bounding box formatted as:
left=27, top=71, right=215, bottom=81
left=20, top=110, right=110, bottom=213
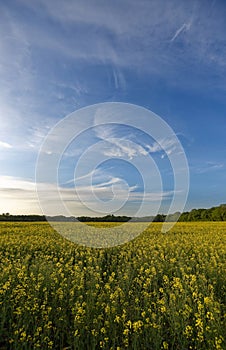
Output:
left=0, top=204, right=226, bottom=222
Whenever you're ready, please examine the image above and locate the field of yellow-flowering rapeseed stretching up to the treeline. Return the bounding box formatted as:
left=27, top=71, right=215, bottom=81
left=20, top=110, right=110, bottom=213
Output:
left=0, top=222, right=226, bottom=350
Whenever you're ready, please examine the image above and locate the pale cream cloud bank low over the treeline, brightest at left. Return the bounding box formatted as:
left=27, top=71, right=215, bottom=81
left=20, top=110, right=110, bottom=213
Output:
left=0, top=176, right=173, bottom=215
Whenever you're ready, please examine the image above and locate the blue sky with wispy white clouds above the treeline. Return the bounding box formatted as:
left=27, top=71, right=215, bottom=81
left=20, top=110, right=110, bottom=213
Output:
left=0, top=0, right=226, bottom=216
